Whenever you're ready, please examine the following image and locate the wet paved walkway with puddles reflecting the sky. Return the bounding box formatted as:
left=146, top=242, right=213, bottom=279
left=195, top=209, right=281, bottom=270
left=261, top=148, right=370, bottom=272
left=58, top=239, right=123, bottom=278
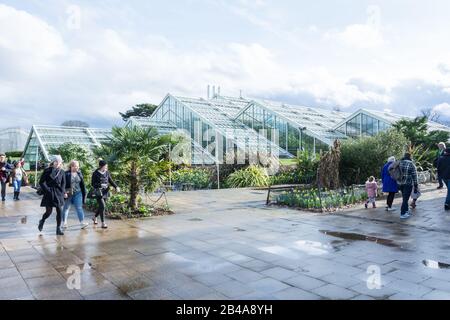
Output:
left=0, top=185, right=450, bottom=299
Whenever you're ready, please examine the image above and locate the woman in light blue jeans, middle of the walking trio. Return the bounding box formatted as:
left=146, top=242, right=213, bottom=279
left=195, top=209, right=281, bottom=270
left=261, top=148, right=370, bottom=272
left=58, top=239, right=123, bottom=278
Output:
left=63, top=160, right=89, bottom=229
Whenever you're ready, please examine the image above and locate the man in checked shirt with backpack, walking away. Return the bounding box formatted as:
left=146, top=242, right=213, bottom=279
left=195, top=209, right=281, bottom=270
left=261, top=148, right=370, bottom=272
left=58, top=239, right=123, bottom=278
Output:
left=399, top=153, right=419, bottom=219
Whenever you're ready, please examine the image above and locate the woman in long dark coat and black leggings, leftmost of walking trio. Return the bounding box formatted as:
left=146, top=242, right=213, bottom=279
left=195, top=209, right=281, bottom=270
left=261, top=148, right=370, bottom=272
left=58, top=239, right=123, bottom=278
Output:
left=38, top=156, right=66, bottom=236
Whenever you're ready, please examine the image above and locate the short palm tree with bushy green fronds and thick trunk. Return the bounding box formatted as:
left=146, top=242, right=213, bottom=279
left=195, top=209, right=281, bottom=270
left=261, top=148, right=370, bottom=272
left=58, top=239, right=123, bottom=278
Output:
left=102, top=126, right=172, bottom=211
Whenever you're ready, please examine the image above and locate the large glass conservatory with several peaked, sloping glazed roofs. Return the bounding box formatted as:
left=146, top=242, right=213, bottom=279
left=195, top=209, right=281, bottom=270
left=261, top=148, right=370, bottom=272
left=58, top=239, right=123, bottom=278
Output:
left=25, top=94, right=450, bottom=169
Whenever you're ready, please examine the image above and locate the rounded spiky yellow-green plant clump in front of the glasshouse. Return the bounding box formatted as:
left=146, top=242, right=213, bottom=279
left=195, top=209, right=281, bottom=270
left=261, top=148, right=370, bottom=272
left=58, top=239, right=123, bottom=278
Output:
left=226, top=165, right=269, bottom=188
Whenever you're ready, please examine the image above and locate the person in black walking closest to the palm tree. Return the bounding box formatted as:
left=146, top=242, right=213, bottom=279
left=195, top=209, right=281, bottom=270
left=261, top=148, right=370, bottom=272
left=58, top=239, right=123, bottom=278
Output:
left=91, top=160, right=120, bottom=229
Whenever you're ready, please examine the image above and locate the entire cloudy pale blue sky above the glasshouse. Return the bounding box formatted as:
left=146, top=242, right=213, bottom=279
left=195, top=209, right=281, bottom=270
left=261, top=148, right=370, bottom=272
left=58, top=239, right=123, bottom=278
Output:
left=0, top=0, right=450, bottom=127
